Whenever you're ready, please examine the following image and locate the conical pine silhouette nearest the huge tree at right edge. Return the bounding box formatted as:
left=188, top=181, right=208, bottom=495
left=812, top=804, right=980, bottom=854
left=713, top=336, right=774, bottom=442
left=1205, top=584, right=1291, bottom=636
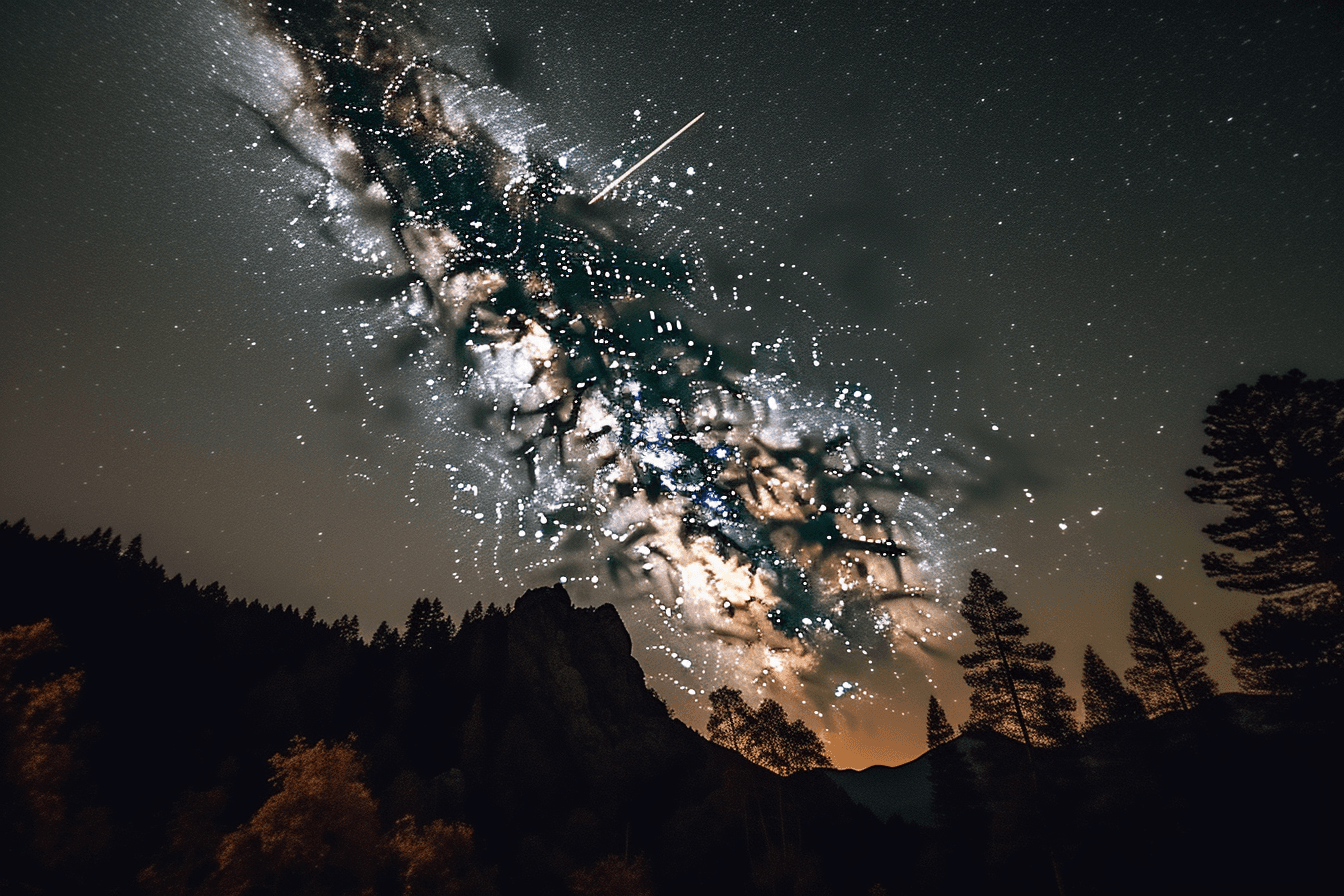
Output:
left=1125, top=582, right=1218, bottom=716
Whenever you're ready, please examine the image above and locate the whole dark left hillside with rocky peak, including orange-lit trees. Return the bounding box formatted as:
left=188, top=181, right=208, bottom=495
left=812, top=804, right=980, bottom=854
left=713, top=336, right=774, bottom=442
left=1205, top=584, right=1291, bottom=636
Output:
left=0, top=524, right=906, bottom=896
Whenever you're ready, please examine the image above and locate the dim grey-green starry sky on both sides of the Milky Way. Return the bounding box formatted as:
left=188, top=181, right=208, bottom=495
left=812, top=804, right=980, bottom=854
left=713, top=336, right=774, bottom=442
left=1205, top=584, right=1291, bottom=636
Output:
left=0, top=0, right=1344, bottom=766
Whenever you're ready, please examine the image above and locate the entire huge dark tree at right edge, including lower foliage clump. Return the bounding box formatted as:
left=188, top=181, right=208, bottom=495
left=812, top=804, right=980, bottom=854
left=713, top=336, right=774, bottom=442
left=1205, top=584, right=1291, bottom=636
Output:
left=1187, top=369, right=1344, bottom=696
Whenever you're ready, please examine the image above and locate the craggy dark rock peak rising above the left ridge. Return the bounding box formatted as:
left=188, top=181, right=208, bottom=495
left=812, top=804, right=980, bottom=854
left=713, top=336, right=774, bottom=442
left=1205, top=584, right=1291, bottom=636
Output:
left=452, top=587, right=715, bottom=852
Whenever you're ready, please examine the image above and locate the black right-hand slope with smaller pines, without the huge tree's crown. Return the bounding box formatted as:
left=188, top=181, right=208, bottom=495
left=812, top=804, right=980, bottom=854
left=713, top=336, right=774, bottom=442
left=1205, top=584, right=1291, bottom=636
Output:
left=921, top=571, right=1344, bottom=893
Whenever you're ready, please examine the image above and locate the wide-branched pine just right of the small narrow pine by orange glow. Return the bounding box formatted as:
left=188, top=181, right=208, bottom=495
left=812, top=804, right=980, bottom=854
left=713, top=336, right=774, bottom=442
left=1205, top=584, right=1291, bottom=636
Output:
left=957, top=570, right=1078, bottom=747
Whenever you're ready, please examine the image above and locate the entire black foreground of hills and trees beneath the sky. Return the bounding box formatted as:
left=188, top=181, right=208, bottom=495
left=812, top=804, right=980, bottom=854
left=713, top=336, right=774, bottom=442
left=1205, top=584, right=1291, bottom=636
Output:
left=0, top=371, right=1344, bottom=895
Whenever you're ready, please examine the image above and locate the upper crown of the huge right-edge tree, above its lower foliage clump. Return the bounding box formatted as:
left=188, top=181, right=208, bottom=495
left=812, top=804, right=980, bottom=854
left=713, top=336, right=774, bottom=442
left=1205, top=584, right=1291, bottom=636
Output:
left=1185, top=371, right=1344, bottom=600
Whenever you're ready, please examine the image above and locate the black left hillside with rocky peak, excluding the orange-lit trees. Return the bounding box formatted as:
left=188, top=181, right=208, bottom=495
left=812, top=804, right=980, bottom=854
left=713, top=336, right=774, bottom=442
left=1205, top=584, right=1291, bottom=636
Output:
left=0, top=523, right=913, bottom=893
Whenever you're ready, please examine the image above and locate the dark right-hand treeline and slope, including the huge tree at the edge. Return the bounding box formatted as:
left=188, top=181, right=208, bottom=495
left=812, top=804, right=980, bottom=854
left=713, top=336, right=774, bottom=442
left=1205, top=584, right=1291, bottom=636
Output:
left=903, top=371, right=1344, bottom=893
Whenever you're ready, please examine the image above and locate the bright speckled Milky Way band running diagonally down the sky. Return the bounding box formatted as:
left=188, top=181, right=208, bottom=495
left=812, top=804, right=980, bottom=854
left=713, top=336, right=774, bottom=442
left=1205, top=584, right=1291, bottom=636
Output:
left=225, top=3, right=983, bottom=715
